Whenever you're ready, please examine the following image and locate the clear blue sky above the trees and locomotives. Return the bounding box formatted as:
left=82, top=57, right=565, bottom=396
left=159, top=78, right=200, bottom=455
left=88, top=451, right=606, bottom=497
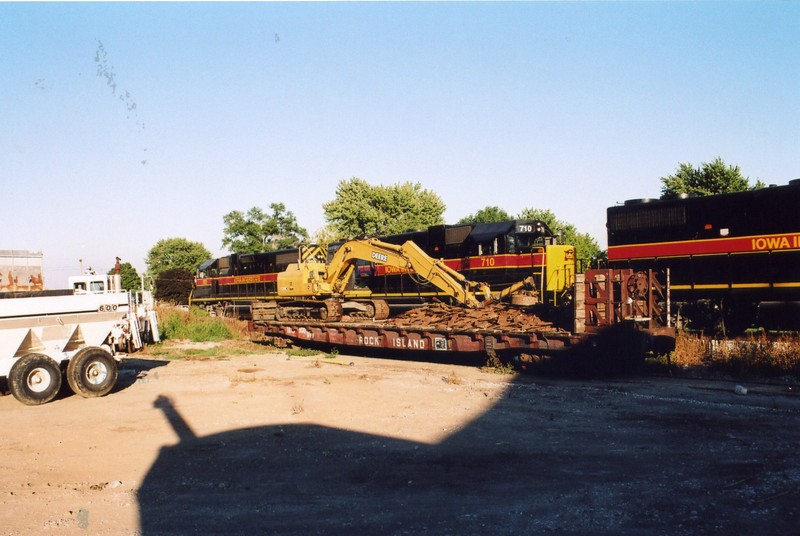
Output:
left=0, top=2, right=800, bottom=288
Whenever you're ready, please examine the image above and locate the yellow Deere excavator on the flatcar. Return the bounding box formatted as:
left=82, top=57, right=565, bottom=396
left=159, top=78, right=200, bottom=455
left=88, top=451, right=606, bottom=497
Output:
left=252, top=239, right=500, bottom=322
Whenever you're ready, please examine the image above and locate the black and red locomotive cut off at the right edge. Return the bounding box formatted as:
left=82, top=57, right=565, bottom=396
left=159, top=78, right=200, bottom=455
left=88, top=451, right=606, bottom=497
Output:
left=606, top=179, right=800, bottom=333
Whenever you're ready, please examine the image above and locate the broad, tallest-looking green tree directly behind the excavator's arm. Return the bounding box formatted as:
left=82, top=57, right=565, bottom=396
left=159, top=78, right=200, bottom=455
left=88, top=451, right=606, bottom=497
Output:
left=322, top=177, right=445, bottom=238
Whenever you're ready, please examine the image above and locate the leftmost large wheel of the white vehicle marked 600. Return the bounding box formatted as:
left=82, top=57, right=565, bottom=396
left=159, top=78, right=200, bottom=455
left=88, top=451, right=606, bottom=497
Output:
left=8, top=354, right=61, bottom=406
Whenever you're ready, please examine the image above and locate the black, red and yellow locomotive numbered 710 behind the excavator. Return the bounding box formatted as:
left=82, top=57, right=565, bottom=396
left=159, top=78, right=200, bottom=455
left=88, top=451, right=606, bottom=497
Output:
left=189, top=220, right=576, bottom=316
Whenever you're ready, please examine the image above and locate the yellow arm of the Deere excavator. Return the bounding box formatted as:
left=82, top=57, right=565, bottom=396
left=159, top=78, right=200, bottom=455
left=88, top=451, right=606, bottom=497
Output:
left=326, top=239, right=492, bottom=307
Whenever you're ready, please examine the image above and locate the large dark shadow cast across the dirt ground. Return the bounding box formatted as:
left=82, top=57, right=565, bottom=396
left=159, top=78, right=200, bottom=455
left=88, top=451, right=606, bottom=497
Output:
left=138, top=332, right=800, bottom=535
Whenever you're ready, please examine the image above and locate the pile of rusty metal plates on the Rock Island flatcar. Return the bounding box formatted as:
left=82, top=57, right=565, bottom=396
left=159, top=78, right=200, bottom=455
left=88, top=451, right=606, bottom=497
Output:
left=386, top=303, right=556, bottom=332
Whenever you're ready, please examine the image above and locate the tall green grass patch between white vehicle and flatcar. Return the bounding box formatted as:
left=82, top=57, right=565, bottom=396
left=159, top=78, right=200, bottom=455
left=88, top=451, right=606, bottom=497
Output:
left=159, top=306, right=243, bottom=342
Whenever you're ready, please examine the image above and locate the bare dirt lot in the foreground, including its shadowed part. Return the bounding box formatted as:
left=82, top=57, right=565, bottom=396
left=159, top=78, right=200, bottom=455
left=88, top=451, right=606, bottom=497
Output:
left=0, top=349, right=800, bottom=535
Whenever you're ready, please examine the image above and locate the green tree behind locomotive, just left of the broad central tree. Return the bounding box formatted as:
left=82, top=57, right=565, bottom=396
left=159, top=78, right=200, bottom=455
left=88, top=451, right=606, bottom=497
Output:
left=222, top=203, right=308, bottom=253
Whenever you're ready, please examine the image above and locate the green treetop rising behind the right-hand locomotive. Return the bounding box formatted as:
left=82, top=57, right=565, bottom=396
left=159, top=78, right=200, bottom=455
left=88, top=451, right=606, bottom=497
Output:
left=661, top=156, right=765, bottom=197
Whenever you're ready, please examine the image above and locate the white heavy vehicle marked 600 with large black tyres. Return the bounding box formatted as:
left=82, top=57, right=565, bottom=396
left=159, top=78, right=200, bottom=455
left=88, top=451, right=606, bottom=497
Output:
left=0, top=274, right=158, bottom=405
